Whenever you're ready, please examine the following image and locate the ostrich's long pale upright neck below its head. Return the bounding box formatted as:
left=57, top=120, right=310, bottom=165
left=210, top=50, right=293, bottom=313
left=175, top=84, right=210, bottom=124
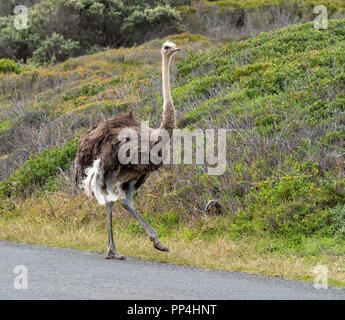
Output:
left=160, top=55, right=176, bottom=135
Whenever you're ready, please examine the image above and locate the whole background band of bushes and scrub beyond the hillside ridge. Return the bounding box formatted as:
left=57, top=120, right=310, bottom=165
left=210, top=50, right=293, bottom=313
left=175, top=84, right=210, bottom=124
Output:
left=0, top=0, right=345, bottom=64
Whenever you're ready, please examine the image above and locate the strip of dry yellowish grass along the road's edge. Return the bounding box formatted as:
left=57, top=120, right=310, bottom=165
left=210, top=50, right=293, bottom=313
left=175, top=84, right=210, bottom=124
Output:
left=0, top=195, right=345, bottom=287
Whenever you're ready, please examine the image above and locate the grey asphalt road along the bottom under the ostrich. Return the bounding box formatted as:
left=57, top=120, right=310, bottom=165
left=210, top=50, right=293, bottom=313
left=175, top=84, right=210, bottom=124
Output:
left=0, top=241, right=345, bottom=300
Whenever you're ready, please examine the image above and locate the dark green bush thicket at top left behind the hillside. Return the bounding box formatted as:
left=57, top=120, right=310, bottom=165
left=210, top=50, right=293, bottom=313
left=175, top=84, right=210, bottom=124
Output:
left=0, top=0, right=189, bottom=63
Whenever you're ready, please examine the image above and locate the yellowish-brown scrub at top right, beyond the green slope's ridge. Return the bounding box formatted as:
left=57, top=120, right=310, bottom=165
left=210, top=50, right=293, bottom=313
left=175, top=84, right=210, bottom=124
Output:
left=178, top=0, right=345, bottom=40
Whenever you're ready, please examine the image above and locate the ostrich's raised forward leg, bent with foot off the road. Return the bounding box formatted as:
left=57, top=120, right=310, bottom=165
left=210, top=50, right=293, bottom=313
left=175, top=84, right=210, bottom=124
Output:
left=122, top=181, right=168, bottom=251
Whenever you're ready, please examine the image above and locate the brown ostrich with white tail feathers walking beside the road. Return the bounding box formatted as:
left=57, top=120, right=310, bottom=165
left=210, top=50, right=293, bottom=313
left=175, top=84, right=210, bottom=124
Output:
left=74, top=41, right=180, bottom=260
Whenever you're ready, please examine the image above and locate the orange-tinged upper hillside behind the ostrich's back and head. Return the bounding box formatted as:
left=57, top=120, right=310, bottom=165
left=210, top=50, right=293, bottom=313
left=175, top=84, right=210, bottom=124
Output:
left=0, top=34, right=221, bottom=177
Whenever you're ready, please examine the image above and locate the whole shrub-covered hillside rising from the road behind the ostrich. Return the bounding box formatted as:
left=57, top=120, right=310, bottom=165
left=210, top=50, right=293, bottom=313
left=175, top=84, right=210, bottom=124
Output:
left=0, top=20, right=345, bottom=284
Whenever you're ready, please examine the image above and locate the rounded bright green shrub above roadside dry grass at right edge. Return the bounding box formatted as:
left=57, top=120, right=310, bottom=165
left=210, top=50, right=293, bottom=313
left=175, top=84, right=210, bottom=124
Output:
left=233, top=162, right=345, bottom=236
